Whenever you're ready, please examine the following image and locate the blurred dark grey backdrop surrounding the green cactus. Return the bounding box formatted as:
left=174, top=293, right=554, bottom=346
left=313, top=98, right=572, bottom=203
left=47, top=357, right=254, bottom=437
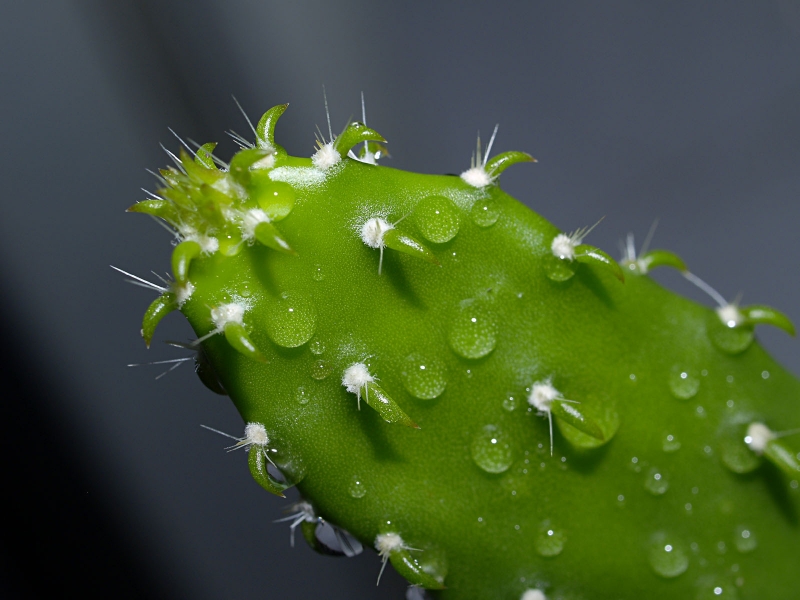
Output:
left=0, top=0, right=800, bottom=600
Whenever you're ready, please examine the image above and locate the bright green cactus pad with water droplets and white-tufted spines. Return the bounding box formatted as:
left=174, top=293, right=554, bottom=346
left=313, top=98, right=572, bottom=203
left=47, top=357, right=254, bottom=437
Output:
left=126, top=105, right=800, bottom=600
